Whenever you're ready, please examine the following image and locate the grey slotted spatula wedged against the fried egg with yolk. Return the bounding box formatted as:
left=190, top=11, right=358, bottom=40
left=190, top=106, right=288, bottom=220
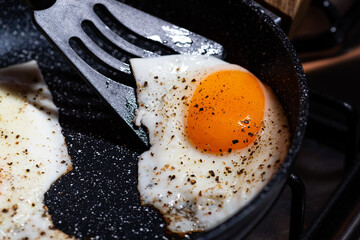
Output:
left=23, top=0, right=224, bottom=145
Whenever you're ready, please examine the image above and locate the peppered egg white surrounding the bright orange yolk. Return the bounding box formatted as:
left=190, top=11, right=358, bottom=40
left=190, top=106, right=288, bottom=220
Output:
left=130, top=55, right=290, bottom=233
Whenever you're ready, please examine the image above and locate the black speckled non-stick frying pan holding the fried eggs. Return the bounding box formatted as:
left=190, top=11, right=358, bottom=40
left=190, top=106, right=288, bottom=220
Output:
left=0, top=0, right=308, bottom=239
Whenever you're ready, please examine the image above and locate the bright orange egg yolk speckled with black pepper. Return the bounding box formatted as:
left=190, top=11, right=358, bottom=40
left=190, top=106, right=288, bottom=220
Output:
left=187, top=70, right=265, bottom=153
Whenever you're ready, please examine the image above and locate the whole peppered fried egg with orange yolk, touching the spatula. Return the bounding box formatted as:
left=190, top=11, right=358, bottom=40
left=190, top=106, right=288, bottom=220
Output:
left=130, top=55, right=290, bottom=233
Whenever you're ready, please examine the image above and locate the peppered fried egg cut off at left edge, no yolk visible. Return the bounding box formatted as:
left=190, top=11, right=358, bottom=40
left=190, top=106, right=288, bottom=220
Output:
left=0, top=61, right=72, bottom=240
